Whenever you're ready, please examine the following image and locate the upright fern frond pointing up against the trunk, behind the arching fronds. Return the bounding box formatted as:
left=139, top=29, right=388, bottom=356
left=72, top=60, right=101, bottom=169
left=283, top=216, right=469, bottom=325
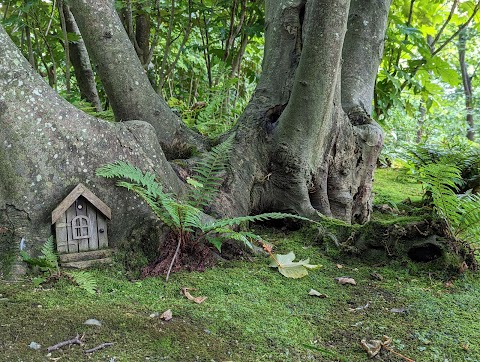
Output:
left=188, top=135, right=234, bottom=207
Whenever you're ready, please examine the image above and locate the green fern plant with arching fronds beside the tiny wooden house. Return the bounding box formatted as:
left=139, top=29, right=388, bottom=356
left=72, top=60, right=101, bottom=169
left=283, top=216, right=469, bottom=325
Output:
left=97, top=137, right=310, bottom=281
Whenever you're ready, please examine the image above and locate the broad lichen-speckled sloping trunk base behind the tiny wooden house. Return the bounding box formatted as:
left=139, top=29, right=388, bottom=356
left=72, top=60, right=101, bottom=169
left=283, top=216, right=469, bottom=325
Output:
left=0, top=27, right=183, bottom=274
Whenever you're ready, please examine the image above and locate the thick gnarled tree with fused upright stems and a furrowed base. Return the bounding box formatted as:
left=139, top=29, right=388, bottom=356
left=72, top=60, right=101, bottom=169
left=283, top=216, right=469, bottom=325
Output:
left=223, top=0, right=390, bottom=223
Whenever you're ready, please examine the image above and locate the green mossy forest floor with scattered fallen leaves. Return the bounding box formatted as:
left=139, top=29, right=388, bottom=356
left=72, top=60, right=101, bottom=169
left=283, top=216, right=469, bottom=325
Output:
left=0, top=170, right=480, bottom=362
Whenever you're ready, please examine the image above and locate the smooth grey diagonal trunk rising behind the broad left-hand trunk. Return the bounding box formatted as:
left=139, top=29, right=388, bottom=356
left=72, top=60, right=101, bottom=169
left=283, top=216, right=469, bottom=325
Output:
left=70, top=0, right=204, bottom=159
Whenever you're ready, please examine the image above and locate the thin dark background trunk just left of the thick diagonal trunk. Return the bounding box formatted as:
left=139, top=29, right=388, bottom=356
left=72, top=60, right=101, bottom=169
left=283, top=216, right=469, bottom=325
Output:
left=63, top=4, right=102, bottom=112
